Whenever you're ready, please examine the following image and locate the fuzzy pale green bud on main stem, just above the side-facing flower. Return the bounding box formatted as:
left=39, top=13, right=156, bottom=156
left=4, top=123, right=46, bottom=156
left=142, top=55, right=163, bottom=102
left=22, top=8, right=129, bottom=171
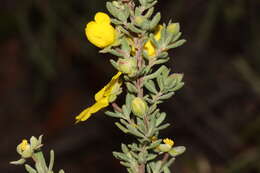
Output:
left=117, top=58, right=137, bottom=77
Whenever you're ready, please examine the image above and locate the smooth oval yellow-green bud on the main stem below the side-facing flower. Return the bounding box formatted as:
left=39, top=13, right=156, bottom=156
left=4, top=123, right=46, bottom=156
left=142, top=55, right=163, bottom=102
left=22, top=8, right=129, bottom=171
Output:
left=131, top=97, right=147, bottom=117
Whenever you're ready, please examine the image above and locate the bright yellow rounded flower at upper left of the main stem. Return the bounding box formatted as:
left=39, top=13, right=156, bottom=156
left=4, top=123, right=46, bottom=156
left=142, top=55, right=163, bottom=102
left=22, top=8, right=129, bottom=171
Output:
left=85, top=12, right=116, bottom=48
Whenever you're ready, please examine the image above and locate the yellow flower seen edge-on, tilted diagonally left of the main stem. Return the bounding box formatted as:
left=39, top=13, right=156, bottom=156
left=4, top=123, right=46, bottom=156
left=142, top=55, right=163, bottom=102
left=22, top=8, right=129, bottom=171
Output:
left=76, top=72, right=122, bottom=123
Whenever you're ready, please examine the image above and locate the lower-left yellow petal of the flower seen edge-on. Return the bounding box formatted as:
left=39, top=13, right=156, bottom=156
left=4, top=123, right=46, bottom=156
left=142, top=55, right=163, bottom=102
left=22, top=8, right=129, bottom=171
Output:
left=76, top=98, right=109, bottom=123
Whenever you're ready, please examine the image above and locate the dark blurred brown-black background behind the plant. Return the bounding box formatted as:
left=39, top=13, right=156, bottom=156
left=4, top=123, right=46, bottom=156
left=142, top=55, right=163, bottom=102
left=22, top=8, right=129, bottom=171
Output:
left=0, top=0, right=260, bottom=173
